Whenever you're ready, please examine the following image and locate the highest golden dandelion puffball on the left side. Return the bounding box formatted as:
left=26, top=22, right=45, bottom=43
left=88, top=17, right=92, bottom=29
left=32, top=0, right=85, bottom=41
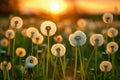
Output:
left=10, top=16, right=23, bottom=29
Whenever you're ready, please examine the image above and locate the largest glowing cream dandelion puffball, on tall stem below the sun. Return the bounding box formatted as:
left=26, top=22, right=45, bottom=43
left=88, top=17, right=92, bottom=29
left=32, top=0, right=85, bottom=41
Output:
left=40, top=21, right=57, bottom=36
